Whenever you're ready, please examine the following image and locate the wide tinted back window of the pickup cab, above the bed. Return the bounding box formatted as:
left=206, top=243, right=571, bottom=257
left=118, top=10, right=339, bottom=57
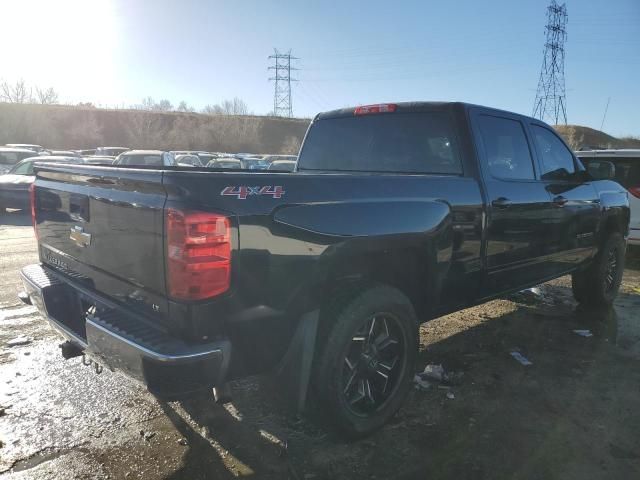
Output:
left=298, top=112, right=462, bottom=175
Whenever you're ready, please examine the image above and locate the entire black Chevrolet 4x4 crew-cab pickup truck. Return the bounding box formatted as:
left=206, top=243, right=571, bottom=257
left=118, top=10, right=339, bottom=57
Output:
left=21, top=102, right=629, bottom=436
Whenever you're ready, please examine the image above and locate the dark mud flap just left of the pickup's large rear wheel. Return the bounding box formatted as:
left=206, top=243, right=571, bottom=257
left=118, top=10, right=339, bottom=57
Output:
left=275, top=310, right=320, bottom=413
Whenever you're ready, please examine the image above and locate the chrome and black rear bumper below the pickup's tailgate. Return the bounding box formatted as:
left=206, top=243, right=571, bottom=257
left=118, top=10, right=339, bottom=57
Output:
left=21, top=265, right=231, bottom=400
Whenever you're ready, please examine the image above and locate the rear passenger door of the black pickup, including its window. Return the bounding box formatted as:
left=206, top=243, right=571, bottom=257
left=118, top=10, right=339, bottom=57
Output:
left=470, top=108, right=553, bottom=295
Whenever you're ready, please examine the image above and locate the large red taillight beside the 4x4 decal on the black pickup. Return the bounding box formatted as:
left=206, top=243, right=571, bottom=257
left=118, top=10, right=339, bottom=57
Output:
left=165, top=209, right=231, bottom=300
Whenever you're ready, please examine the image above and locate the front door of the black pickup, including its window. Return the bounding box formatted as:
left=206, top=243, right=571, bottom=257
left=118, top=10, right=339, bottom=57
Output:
left=529, top=121, right=600, bottom=266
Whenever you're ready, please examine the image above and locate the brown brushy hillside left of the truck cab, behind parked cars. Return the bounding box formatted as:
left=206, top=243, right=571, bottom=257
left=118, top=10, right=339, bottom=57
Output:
left=0, top=103, right=309, bottom=154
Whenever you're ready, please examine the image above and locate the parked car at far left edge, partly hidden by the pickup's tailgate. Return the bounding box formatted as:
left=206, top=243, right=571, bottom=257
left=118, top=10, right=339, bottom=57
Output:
left=0, top=157, right=84, bottom=213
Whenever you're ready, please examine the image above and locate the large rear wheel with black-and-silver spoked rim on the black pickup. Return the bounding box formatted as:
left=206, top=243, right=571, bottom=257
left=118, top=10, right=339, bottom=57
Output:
left=314, top=285, right=418, bottom=438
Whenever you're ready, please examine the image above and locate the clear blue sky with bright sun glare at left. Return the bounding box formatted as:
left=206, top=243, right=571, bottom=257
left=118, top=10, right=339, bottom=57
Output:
left=0, top=0, right=640, bottom=136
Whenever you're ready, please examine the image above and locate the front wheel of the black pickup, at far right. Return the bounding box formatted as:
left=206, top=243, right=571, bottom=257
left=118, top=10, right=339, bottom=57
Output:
left=571, top=233, right=626, bottom=307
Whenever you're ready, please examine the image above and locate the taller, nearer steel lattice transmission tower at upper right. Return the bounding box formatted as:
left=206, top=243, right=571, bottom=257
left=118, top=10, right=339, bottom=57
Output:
left=533, top=0, right=568, bottom=125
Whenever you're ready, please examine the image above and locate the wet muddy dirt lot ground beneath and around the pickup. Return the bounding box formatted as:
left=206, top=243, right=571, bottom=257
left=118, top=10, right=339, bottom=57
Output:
left=0, top=213, right=640, bottom=480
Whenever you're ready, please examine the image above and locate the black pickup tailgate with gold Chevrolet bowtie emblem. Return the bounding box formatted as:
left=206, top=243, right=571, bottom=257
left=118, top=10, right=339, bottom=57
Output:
left=34, top=165, right=168, bottom=319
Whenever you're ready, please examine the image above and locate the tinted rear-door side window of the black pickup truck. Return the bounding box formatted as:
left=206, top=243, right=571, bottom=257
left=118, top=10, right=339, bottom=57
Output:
left=478, top=115, right=535, bottom=180
